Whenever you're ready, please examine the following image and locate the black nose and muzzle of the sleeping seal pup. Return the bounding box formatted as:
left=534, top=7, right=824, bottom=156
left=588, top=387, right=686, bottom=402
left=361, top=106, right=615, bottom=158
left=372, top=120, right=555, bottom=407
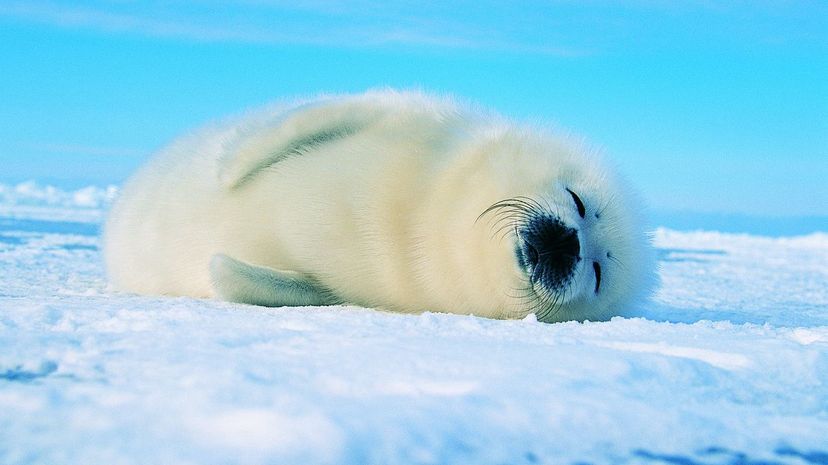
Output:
left=518, top=216, right=581, bottom=289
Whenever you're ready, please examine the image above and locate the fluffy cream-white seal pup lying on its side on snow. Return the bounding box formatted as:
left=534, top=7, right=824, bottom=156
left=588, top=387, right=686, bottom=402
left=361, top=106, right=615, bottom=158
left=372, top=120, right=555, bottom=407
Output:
left=104, top=90, right=653, bottom=322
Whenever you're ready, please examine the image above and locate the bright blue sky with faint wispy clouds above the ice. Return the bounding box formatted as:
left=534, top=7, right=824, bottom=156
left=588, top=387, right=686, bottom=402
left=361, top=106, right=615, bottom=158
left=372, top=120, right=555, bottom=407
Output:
left=0, top=0, right=828, bottom=217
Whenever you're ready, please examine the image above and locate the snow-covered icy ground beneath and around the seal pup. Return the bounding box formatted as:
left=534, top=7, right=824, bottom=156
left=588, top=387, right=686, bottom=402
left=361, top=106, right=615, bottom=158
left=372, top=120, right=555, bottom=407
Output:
left=0, top=185, right=828, bottom=465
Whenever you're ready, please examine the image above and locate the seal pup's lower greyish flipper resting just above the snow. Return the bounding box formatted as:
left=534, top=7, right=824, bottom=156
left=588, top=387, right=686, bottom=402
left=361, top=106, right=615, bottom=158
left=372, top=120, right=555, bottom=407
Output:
left=210, top=254, right=342, bottom=307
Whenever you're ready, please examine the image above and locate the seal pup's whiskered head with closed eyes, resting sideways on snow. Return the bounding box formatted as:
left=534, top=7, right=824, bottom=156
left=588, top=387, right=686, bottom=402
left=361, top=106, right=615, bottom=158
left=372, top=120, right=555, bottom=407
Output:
left=472, top=130, right=653, bottom=322
